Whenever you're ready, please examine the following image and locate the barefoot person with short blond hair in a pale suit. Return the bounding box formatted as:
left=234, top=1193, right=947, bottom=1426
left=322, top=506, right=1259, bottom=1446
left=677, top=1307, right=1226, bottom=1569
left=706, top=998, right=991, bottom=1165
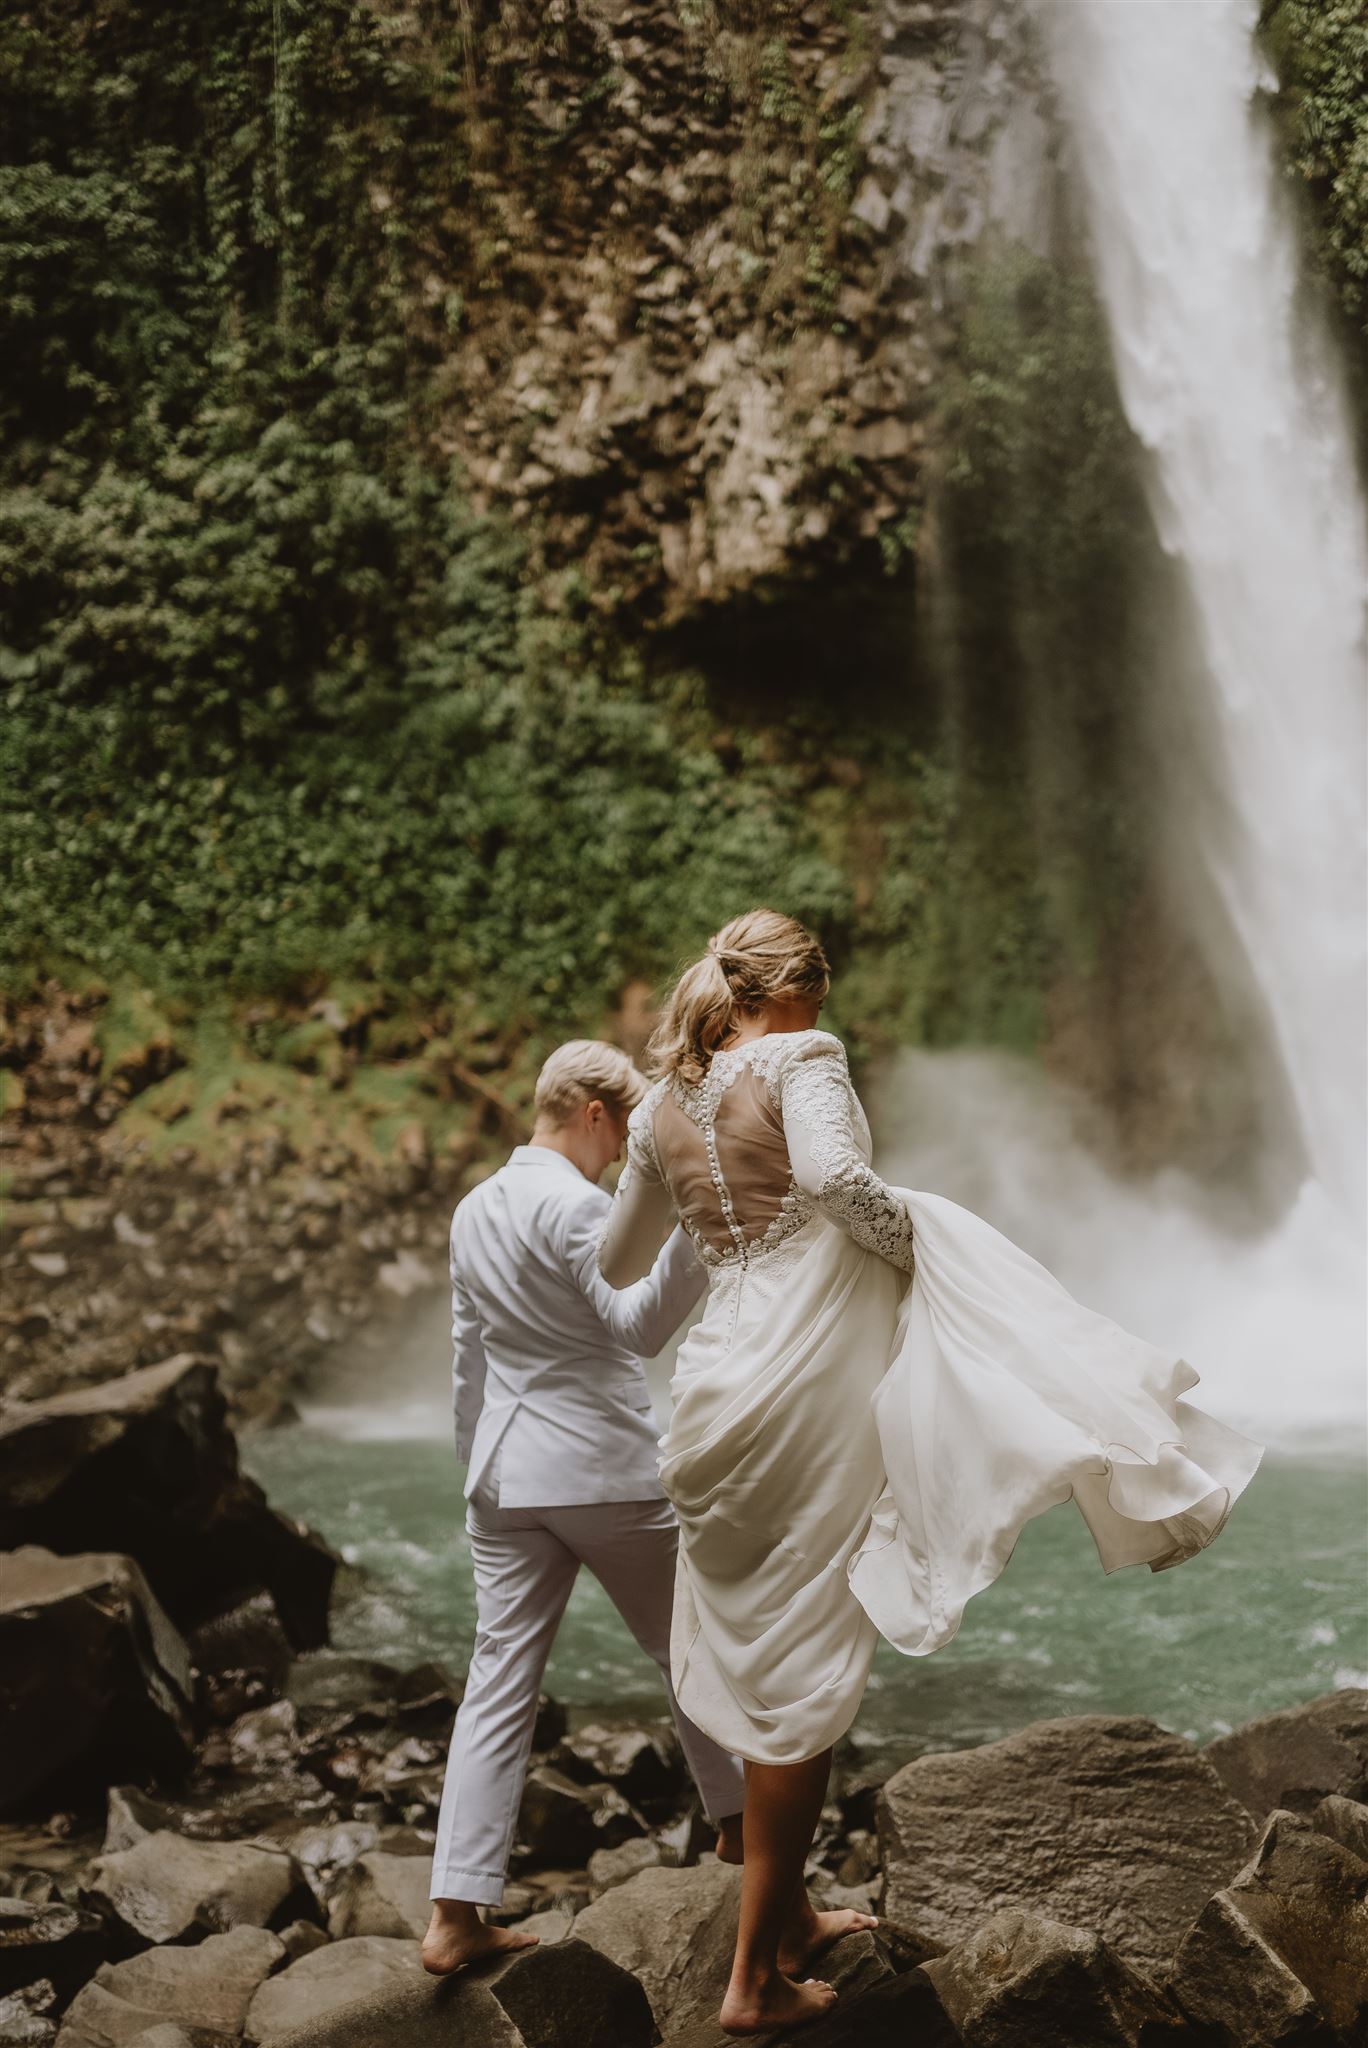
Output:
left=422, top=1038, right=745, bottom=1976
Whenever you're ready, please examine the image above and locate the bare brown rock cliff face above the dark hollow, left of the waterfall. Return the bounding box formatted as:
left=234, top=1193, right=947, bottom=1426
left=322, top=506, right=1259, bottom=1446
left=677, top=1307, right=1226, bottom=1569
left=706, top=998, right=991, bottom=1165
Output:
left=423, top=0, right=1059, bottom=623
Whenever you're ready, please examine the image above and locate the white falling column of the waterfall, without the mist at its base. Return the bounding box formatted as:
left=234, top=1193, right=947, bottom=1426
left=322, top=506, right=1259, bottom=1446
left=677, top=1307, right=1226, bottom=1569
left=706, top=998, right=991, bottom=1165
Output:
left=1042, top=0, right=1368, bottom=1227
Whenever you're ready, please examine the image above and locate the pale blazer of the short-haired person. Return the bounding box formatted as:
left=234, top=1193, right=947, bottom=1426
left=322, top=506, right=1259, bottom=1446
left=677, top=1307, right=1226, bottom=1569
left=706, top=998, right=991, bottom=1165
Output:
left=451, top=1145, right=704, bottom=1507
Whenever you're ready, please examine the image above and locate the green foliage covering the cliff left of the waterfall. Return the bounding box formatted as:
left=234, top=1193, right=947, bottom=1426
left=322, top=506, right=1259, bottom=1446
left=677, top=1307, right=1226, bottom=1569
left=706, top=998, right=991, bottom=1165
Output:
left=0, top=0, right=1135, bottom=1089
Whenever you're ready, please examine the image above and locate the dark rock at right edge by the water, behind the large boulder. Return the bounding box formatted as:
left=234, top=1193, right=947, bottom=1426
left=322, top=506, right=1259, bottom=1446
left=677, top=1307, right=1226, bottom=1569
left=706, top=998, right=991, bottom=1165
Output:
left=1202, top=1686, right=1368, bottom=1821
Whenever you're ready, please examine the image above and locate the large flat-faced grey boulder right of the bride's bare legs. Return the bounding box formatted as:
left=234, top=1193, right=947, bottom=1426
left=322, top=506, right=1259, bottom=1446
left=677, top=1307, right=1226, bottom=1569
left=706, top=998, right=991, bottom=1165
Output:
left=879, top=1714, right=1255, bottom=1974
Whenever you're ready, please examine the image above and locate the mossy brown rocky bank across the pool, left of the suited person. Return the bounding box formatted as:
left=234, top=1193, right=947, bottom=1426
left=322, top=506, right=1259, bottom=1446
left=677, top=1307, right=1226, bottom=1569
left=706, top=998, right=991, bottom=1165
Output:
left=0, top=981, right=511, bottom=1425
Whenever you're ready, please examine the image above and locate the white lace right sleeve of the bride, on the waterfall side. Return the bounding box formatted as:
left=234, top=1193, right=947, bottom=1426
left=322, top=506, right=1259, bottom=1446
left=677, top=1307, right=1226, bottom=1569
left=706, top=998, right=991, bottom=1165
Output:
left=780, top=1032, right=913, bottom=1272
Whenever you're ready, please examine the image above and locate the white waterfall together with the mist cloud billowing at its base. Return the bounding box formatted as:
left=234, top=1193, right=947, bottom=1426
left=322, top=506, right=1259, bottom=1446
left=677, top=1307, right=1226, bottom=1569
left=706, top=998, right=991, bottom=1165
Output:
left=879, top=0, right=1368, bottom=1452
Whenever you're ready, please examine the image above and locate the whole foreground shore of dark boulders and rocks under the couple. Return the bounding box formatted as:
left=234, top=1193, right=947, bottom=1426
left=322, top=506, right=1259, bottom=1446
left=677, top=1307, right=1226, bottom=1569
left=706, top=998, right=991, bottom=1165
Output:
left=0, top=1354, right=1368, bottom=2048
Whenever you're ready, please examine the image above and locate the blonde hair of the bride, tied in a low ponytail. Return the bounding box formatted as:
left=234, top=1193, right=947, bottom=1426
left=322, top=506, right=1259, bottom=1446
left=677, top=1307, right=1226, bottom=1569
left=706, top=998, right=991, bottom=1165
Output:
left=647, top=909, right=831, bottom=1083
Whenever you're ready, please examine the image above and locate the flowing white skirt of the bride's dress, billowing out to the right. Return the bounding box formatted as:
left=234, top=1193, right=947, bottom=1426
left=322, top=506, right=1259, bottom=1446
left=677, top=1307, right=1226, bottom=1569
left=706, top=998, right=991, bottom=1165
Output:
left=661, top=1188, right=1264, bottom=1763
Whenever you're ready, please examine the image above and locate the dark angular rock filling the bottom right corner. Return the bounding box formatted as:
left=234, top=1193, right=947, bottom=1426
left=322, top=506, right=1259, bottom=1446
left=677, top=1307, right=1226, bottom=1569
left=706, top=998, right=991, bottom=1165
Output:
left=1171, top=1810, right=1368, bottom=2048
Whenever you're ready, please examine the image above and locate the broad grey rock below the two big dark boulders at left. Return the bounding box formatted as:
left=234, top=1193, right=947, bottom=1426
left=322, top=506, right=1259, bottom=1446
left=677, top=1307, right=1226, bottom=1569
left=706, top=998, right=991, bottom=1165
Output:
left=86, top=1833, right=317, bottom=1942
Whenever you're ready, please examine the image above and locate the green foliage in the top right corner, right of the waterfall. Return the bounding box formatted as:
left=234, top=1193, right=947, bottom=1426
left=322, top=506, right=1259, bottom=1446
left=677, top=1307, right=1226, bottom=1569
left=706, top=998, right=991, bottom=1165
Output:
left=1264, top=0, right=1368, bottom=342
